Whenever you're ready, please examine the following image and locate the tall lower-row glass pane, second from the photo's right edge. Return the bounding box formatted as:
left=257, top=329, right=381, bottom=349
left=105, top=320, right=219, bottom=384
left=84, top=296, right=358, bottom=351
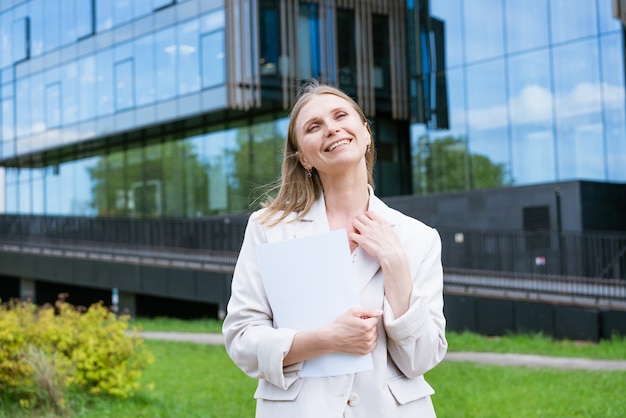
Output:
left=553, top=39, right=605, bottom=180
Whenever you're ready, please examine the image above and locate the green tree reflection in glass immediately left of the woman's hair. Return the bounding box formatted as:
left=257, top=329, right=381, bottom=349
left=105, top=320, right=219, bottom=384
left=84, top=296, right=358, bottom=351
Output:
left=226, top=123, right=283, bottom=210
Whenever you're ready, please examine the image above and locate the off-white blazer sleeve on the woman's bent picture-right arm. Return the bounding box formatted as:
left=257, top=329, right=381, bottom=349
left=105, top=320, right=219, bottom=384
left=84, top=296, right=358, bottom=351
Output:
left=383, top=224, right=448, bottom=378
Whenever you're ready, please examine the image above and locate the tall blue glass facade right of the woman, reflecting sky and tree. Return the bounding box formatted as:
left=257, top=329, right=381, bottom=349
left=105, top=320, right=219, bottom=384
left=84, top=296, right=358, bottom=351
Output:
left=411, top=0, right=626, bottom=193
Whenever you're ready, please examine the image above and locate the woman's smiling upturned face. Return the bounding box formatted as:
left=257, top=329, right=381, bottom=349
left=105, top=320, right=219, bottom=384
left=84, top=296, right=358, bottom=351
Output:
left=295, top=94, right=371, bottom=175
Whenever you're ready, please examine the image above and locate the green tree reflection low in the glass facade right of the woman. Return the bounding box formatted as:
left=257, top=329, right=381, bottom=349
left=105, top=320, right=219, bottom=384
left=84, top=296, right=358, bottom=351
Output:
left=414, top=135, right=507, bottom=193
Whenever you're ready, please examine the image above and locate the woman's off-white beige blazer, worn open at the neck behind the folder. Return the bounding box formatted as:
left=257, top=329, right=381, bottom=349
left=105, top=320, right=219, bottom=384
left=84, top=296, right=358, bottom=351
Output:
left=223, top=189, right=447, bottom=418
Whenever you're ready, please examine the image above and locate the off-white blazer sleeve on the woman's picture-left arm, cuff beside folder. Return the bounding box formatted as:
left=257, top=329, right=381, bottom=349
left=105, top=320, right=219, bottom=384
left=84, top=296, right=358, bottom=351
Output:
left=222, top=215, right=302, bottom=389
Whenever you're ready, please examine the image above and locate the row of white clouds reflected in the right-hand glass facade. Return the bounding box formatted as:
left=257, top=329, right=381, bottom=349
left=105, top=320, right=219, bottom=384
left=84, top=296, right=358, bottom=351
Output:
left=455, top=83, right=626, bottom=130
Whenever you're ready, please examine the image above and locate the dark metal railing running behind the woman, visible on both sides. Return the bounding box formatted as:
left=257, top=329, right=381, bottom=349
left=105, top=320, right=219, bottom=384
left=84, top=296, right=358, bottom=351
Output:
left=0, top=214, right=626, bottom=279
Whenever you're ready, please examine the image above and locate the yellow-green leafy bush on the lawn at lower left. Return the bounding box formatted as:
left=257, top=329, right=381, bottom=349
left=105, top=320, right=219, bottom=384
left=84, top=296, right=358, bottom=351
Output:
left=0, top=299, right=152, bottom=411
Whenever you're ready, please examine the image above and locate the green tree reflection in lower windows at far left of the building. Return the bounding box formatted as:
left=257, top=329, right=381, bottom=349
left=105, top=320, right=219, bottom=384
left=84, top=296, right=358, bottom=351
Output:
left=89, top=141, right=208, bottom=217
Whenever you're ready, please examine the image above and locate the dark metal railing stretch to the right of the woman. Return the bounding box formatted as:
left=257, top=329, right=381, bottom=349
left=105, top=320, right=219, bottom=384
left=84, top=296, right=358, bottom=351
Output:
left=438, top=228, right=626, bottom=279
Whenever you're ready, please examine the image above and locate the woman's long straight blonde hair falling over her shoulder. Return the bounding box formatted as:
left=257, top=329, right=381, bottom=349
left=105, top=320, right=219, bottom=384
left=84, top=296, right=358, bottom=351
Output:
left=261, top=80, right=376, bottom=226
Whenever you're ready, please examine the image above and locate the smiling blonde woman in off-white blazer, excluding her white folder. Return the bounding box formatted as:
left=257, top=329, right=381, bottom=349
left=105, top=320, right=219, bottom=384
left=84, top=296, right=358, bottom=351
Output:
left=223, top=81, right=447, bottom=418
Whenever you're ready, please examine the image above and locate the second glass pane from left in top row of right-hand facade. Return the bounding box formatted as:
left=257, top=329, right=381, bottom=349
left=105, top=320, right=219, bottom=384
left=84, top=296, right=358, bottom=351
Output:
left=464, top=0, right=504, bottom=62
